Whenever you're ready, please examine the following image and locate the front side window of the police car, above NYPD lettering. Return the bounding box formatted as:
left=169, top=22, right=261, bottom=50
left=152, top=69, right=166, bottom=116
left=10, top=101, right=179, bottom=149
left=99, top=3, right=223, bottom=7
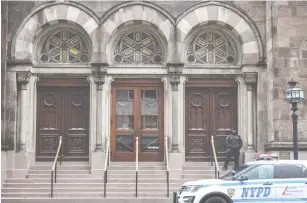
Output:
left=244, top=164, right=274, bottom=180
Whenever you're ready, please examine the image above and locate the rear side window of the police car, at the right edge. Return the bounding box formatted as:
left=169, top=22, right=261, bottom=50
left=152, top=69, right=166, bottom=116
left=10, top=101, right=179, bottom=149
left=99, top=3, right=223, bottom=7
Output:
left=280, top=164, right=307, bottom=178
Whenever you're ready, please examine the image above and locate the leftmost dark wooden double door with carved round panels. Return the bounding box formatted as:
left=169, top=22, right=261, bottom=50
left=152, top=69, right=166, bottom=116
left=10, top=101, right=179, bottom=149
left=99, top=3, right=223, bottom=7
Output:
left=36, top=87, right=89, bottom=161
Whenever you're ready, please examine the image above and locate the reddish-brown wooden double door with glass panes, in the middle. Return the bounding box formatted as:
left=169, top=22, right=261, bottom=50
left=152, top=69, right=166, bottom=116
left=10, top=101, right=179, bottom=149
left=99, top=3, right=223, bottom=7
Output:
left=111, top=83, right=164, bottom=162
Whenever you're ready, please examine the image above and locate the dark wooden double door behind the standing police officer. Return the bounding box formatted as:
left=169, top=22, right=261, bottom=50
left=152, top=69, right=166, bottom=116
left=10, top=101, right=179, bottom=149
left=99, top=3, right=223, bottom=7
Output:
left=185, top=87, right=237, bottom=161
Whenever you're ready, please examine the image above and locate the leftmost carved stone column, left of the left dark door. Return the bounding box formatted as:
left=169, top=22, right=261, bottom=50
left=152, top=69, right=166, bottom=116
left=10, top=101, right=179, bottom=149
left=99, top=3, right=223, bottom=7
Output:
left=17, top=71, right=31, bottom=152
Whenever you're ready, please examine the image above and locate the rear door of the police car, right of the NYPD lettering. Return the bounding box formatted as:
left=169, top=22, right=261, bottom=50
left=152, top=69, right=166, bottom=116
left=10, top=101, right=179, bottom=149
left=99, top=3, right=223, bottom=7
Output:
left=276, top=163, right=307, bottom=203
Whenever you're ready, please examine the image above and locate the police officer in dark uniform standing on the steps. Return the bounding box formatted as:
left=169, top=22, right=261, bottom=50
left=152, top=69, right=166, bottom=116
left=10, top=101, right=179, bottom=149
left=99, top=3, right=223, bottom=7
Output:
left=223, top=129, right=243, bottom=170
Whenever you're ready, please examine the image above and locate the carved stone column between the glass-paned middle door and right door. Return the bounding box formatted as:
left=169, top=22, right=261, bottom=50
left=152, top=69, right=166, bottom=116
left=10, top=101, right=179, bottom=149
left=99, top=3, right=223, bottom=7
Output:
left=167, top=63, right=184, bottom=153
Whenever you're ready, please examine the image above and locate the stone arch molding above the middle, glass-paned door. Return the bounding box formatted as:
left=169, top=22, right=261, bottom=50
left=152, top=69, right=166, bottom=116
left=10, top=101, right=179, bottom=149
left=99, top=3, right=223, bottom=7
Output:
left=100, top=2, right=175, bottom=60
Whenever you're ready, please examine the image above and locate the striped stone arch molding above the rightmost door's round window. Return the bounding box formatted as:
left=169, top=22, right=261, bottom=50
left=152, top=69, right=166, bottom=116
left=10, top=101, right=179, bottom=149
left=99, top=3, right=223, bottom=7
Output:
left=176, top=2, right=264, bottom=64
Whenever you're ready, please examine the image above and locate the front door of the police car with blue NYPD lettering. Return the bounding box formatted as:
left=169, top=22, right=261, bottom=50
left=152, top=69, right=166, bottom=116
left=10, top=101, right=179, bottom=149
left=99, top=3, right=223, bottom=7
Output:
left=232, top=164, right=275, bottom=203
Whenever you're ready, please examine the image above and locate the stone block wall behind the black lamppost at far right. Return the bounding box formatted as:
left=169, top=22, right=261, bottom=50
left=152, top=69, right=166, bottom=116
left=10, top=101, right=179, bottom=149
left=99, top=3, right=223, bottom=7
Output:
left=273, top=1, right=307, bottom=143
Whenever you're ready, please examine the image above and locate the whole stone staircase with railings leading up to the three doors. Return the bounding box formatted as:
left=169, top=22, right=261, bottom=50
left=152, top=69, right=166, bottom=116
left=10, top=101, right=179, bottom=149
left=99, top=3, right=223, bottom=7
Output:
left=1, top=162, right=231, bottom=200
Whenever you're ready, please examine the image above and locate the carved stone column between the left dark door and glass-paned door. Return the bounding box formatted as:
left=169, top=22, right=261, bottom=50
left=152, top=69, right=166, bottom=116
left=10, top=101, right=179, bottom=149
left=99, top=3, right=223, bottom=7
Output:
left=91, top=62, right=108, bottom=152
